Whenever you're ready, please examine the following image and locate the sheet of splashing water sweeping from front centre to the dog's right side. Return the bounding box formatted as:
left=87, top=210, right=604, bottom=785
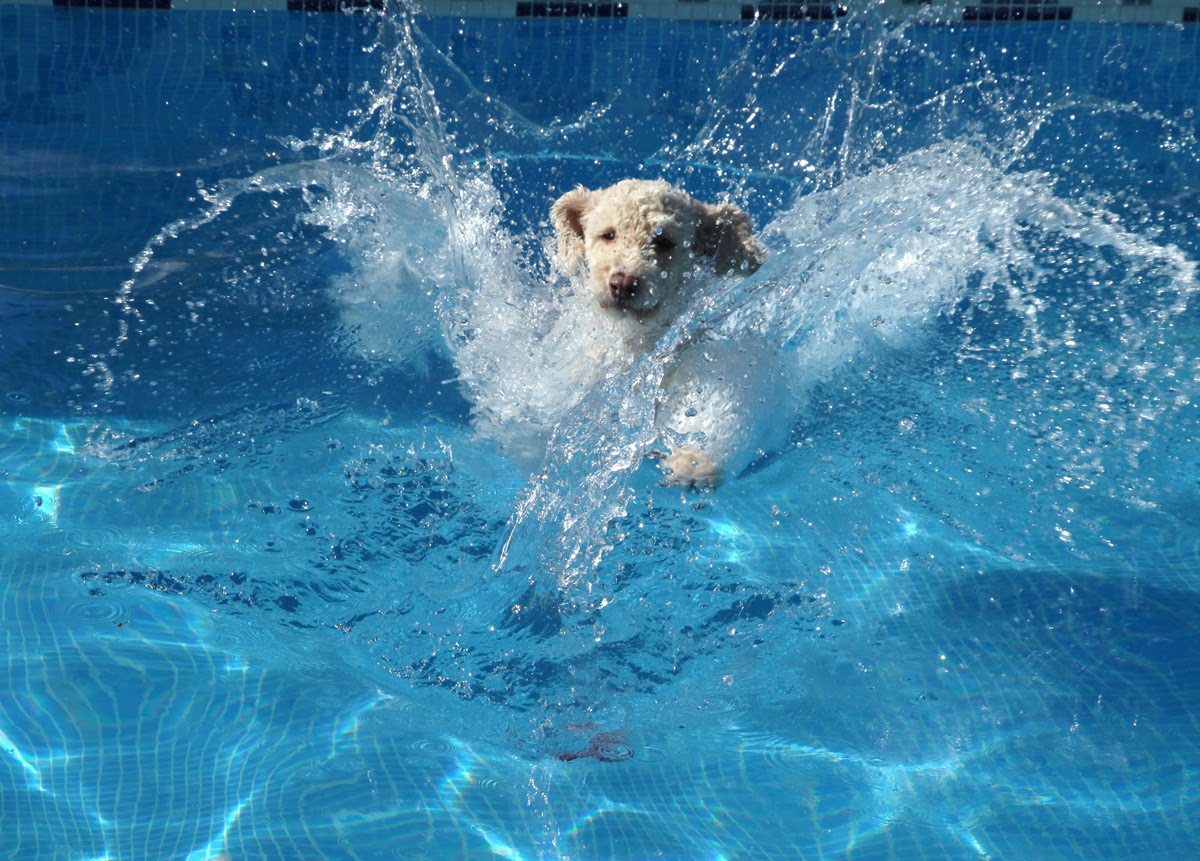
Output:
left=497, top=140, right=1196, bottom=600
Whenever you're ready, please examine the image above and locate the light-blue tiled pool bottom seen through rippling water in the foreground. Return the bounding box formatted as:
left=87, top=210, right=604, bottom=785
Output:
left=7, top=416, right=1200, bottom=859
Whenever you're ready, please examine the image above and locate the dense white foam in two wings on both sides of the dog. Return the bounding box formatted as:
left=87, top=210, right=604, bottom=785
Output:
left=335, top=142, right=1195, bottom=506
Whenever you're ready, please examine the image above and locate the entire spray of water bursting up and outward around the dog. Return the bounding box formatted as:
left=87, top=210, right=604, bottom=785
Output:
left=103, top=10, right=1196, bottom=733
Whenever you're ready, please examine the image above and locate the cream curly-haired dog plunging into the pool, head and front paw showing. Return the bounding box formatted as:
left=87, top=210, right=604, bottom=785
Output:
left=551, top=180, right=773, bottom=487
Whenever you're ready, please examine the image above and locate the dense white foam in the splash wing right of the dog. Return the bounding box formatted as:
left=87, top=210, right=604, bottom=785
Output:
left=748, top=143, right=1044, bottom=384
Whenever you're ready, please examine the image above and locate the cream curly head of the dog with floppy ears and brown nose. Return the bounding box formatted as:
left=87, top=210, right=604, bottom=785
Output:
left=550, top=180, right=762, bottom=315
